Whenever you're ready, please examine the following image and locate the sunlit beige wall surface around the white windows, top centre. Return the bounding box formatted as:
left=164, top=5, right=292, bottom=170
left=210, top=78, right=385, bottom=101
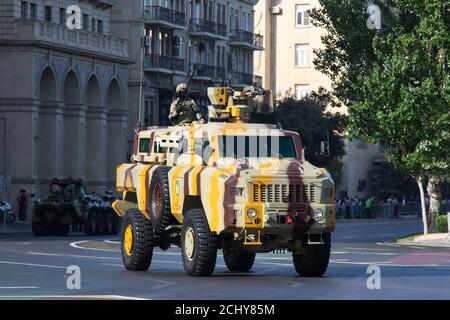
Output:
left=255, top=0, right=331, bottom=94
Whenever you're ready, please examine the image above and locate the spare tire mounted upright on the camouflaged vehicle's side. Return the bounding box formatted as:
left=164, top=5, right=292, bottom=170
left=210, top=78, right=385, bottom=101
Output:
left=148, top=167, right=172, bottom=235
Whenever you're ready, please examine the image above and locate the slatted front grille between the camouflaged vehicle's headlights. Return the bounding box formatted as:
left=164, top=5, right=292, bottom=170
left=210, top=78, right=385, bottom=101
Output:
left=252, top=184, right=316, bottom=203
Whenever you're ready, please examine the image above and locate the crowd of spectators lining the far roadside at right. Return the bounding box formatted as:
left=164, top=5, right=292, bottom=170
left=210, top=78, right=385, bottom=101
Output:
left=335, top=195, right=450, bottom=219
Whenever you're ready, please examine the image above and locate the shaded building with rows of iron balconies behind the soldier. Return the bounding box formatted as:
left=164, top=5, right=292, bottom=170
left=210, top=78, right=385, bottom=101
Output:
left=112, top=0, right=262, bottom=143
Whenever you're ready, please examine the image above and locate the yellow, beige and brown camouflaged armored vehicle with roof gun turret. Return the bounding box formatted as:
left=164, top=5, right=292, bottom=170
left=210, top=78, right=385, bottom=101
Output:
left=113, top=87, right=336, bottom=276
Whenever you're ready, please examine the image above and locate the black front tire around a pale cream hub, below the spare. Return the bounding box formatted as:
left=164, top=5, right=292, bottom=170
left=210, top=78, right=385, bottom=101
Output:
left=181, top=209, right=219, bottom=276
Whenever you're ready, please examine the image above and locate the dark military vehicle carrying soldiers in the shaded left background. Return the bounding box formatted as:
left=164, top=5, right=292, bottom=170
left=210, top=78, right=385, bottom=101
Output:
left=32, top=178, right=120, bottom=236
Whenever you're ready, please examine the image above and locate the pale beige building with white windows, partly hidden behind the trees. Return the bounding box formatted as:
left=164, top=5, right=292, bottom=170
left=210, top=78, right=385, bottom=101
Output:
left=255, top=0, right=382, bottom=197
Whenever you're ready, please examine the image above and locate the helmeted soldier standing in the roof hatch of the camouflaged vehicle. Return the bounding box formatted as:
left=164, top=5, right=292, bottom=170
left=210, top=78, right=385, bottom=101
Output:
left=169, top=83, right=205, bottom=126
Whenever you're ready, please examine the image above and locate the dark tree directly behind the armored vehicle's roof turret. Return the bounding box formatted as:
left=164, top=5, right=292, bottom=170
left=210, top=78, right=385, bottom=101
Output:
left=275, top=90, right=346, bottom=184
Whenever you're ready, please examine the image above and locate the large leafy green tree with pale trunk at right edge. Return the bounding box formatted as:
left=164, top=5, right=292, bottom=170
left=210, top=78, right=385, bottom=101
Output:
left=311, top=0, right=450, bottom=233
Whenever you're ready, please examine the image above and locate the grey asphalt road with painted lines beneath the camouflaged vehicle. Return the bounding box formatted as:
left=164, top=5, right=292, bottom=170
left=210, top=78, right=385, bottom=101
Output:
left=0, top=219, right=450, bottom=300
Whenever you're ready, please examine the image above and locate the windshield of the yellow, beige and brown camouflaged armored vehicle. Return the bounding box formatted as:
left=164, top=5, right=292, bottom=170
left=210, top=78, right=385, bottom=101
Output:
left=218, top=136, right=297, bottom=159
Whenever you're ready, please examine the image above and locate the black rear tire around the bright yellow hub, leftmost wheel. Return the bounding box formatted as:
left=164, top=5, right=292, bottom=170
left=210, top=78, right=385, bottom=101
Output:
left=121, top=209, right=153, bottom=271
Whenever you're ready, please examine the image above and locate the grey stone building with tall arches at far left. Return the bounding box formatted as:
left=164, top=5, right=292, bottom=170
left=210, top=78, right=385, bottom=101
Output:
left=0, top=0, right=132, bottom=218
